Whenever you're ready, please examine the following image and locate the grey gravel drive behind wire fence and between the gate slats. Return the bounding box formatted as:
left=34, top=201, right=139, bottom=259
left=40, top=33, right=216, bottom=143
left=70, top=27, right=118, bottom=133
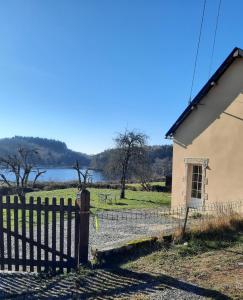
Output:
left=1, top=210, right=178, bottom=260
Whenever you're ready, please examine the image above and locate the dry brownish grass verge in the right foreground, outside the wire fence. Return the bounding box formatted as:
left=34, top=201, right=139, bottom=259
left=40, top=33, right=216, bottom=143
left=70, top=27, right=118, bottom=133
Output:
left=123, top=213, right=243, bottom=299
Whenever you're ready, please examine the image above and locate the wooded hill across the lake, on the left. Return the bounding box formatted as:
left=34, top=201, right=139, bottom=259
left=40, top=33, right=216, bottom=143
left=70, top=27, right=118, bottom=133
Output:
left=0, top=136, right=90, bottom=167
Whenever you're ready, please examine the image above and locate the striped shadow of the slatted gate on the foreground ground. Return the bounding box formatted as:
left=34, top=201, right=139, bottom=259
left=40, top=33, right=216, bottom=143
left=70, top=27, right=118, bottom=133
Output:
left=0, top=268, right=230, bottom=300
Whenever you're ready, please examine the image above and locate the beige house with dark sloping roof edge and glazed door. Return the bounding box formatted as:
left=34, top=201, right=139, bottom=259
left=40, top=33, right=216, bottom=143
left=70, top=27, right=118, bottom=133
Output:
left=166, top=48, right=243, bottom=208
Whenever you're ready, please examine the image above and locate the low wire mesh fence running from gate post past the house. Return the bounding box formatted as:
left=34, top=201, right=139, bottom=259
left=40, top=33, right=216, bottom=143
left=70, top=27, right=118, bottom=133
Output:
left=90, top=200, right=243, bottom=255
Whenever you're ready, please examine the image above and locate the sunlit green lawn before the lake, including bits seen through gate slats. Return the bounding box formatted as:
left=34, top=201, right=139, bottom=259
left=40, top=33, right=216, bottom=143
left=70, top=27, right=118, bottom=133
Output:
left=0, top=188, right=171, bottom=230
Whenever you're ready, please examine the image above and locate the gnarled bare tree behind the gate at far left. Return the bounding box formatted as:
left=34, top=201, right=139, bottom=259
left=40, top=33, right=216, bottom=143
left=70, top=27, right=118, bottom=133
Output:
left=0, top=147, right=46, bottom=198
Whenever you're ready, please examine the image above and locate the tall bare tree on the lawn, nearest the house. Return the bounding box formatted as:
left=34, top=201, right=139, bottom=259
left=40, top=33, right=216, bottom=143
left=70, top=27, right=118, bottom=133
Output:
left=108, top=130, right=147, bottom=199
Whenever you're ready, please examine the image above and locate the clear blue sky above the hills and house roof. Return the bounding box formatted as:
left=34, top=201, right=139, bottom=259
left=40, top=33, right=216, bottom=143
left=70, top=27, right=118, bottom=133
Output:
left=0, top=0, right=243, bottom=153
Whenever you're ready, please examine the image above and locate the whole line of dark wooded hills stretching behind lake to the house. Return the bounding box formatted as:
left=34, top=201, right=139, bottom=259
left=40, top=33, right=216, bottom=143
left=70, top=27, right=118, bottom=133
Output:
left=0, top=136, right=172, bottom=181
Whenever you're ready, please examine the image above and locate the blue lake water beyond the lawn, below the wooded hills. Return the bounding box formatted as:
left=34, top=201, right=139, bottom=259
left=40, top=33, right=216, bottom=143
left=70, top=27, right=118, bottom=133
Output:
left=0, top=168, right=105, bottom=182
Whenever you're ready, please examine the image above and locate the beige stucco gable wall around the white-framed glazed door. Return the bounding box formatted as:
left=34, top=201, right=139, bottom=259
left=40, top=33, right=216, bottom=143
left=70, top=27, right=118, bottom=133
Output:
left=172, top=59, right=243, bottom=207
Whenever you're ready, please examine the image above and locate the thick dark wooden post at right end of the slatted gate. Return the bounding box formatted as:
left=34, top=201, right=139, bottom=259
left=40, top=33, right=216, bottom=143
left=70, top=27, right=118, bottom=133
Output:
left=76, top=190, right=90, bottom=264
